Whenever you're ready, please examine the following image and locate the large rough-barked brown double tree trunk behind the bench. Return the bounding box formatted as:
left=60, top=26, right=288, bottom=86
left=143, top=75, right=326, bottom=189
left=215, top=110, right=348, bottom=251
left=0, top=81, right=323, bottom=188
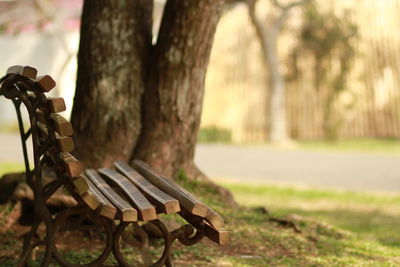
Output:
left=72, top=0, right=235, bottom=204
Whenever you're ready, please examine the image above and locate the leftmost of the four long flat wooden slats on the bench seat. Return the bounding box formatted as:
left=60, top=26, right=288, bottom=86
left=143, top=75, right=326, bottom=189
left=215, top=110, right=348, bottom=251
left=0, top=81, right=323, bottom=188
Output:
left=85, top=169, right=137, bottom=222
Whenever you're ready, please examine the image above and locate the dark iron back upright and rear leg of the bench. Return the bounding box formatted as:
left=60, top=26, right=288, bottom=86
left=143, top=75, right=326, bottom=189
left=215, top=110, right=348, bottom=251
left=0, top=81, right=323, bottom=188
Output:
left=0, top=74, right=57, bottom=266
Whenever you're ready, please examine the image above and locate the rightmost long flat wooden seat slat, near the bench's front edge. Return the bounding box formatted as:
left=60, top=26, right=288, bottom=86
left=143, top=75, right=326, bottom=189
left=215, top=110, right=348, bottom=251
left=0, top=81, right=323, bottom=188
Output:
left=133, top=160, right=208, bottom=217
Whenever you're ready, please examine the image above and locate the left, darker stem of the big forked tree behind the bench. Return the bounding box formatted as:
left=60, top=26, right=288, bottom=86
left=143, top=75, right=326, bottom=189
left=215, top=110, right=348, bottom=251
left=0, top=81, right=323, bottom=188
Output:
left=71, top=0, right=152, bottom=168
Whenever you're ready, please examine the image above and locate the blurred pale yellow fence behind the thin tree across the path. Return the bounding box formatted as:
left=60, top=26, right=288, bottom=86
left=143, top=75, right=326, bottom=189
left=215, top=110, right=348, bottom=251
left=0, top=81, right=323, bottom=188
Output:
left=202, top=0, right=400, bottom=143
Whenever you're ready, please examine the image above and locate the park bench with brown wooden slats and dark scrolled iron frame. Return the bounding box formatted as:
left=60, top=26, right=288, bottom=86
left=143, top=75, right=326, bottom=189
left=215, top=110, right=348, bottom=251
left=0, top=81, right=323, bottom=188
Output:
left=0, top=66, right=230, bottom=266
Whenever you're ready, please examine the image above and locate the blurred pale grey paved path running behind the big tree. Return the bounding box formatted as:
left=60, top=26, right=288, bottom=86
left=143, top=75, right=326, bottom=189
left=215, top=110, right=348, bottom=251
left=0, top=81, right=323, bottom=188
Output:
left=0, top=134, right=400, bottom=192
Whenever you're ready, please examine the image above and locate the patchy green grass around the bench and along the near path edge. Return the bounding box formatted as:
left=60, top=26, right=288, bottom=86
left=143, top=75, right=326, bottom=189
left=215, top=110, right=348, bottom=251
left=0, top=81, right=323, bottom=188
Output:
left=0, top=161, right=400, bottom=267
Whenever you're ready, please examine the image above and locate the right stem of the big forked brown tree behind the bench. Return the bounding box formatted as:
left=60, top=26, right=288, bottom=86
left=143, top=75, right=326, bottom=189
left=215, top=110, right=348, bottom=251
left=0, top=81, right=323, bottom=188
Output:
left=134, top=0, right=224, bottom=178
